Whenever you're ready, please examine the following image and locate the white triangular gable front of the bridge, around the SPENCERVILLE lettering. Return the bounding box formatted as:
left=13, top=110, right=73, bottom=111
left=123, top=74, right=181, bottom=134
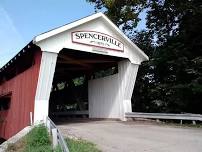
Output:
left=33, top=13, right=149, bottom=64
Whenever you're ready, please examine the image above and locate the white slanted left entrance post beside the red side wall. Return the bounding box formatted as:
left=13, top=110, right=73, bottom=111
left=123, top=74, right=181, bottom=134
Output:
left=34, top=52, right=58, bottom=123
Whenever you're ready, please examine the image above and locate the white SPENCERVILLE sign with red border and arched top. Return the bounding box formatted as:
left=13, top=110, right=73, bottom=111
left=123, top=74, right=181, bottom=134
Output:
left=72, top=31, right=124, bottom=52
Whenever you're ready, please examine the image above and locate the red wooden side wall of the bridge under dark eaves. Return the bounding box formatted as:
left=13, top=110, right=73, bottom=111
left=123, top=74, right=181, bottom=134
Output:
left=0, top=45, right=41, bottom=139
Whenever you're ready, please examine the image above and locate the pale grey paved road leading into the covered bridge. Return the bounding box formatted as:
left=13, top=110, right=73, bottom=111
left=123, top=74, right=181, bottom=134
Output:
left=59, top=121, right=202, bottom=152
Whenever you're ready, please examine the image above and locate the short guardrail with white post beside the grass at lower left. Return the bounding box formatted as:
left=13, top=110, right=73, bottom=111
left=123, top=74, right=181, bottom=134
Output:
left=46, top=117, right=69, bottom=152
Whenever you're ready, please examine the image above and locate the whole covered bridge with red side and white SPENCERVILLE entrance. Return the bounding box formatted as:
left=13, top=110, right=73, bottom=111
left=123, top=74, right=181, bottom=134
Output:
left=0, top=13, right=148, bottom=139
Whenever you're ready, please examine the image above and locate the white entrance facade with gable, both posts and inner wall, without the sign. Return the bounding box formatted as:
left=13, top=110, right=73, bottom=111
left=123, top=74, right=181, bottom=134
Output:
left=33, top=13, right=148, bottom=122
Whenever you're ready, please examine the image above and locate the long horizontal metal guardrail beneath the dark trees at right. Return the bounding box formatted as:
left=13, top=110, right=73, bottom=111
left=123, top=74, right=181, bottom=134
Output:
left=125, top=112, right=202, bottom=124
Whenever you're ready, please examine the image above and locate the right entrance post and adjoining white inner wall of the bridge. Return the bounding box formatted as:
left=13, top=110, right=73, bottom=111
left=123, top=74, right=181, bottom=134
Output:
left=88, top=60, right=138, bottom=120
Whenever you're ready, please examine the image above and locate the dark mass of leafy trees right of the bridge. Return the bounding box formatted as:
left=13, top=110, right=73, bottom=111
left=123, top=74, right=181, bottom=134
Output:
left=88, top=0, right=202, bottom=113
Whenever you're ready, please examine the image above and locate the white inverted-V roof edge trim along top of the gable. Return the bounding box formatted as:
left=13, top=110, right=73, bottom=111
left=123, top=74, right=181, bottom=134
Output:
left=33, top=12, right=149, bottom=61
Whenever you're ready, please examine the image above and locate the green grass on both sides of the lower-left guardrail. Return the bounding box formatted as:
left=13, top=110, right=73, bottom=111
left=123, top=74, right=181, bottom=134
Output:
left=6, top=125, right=100, bottom=152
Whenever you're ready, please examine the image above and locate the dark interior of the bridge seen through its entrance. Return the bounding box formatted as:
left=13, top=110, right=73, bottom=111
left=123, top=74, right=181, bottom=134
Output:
left=49, top=49, right=123, bottom=118
